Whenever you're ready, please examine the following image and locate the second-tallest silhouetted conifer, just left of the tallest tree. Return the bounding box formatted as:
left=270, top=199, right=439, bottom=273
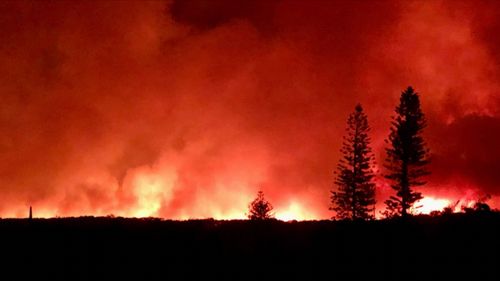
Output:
left=330, top=104, right=375, bottom=220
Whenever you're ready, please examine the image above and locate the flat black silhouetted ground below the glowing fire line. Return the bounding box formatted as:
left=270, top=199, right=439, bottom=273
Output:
left=0, top=213, right=500, bottom=280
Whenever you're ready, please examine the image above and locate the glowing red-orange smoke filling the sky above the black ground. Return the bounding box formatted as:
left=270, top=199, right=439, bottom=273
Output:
left=0, top=1, right=500, bottom=219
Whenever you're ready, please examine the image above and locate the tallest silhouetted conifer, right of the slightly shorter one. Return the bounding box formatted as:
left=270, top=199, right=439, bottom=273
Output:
left=384, top=87, right=429, bottom=217
